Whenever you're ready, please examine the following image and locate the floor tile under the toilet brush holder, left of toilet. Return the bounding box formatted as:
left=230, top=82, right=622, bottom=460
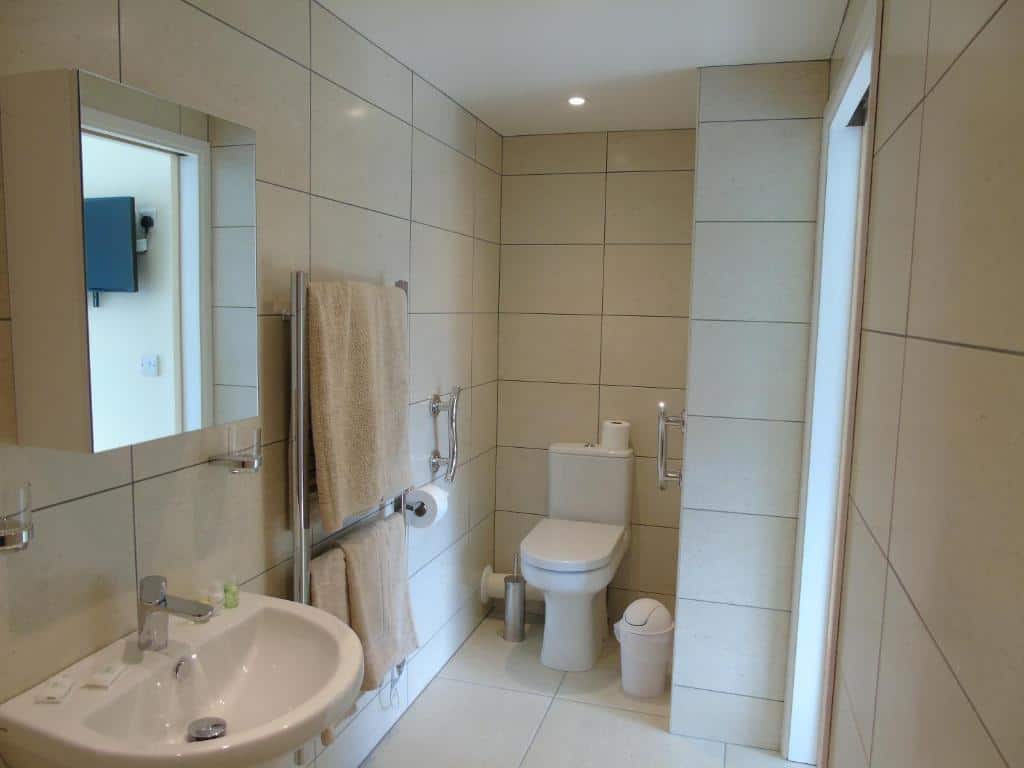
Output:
left=440, top=618, right=564, bottom=696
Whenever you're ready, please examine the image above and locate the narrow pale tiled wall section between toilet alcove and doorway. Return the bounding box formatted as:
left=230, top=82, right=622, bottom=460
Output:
left=672, top=61, right=828, bottom=749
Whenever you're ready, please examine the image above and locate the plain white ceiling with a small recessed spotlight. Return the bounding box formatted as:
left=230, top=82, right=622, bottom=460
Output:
left=321, top=0, right=847, bottom=135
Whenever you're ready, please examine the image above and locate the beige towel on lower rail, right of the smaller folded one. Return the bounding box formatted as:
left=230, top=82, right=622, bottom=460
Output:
left=341, top=514, right=419, bottom=690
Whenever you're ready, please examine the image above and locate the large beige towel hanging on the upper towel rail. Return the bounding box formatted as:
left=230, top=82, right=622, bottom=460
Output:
left=309, top=283, right=412, bottom=531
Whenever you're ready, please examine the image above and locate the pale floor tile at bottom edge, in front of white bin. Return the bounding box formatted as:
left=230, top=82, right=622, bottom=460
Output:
left=523, top=699, right=724, bottom=768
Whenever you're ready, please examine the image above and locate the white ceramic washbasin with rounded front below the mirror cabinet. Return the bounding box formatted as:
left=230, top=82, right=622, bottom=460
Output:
left=0, top=594, right=362, bottom=768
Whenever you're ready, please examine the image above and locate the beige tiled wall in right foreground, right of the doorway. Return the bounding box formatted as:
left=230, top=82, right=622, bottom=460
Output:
left=831, top=0, right=1024, bottom=768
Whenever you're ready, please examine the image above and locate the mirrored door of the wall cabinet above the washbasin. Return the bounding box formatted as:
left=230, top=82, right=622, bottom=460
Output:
left=79, top=73, right=258, bottom=452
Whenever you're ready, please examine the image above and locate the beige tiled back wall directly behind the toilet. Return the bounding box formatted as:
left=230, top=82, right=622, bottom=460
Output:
left=495, top=130, right=694, bottom=618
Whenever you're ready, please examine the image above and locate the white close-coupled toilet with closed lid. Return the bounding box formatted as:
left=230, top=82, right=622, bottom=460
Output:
left=519, top=442, right=633, bottom=672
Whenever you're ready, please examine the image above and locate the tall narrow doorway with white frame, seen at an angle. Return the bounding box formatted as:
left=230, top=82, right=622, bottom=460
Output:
left=782, top=10, right=876, bottom=766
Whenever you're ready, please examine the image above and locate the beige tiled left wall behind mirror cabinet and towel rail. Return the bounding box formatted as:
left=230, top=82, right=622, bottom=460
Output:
left=0, top=0, right=497, bottom=766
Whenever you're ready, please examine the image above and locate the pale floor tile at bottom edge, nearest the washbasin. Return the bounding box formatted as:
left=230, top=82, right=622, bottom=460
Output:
left=366, top=678, right=551, bottom=768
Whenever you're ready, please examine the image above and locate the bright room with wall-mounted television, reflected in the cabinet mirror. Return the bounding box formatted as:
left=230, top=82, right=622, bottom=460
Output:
left=82, top=131, right=186, bottom=451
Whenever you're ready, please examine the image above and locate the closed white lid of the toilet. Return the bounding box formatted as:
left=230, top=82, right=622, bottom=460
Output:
left=519, top=518, right=625, bottom=572
